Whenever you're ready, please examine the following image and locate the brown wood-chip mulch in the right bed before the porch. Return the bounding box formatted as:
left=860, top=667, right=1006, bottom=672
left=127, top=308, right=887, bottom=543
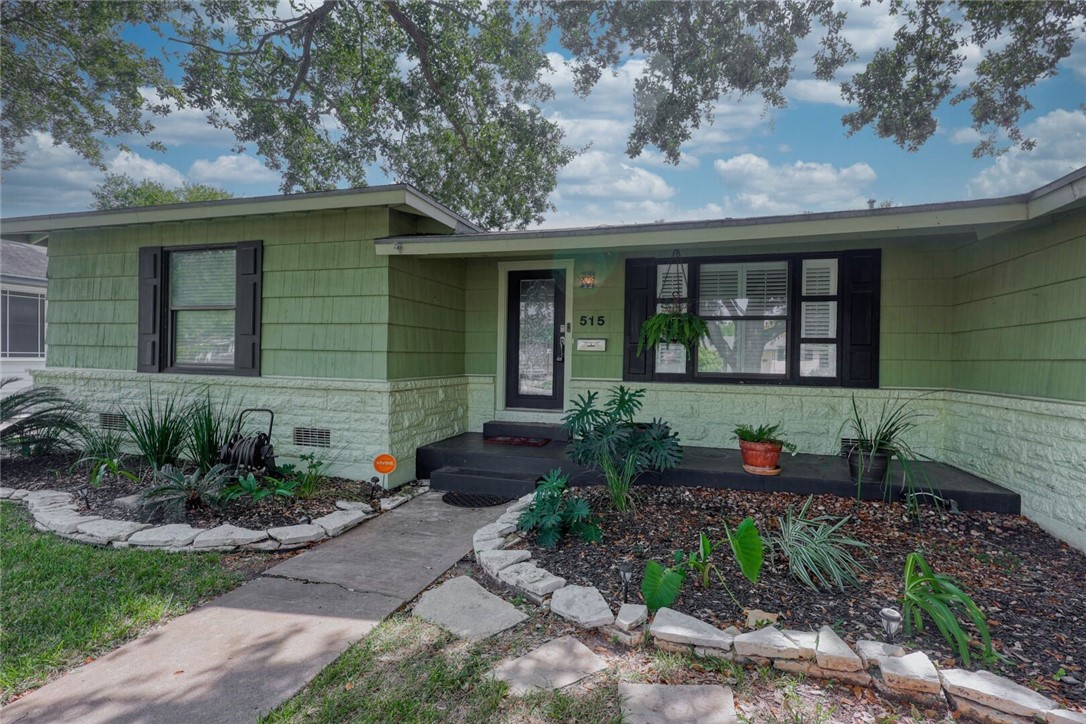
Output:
left=525, top=486, right=1086, bottom=704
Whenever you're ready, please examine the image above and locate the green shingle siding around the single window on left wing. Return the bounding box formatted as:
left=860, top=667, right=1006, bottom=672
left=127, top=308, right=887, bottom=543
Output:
left=47, top=208, right=389, bottom=380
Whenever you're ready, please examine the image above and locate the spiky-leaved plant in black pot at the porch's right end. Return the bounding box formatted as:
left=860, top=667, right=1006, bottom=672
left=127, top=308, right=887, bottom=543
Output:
left=842, top=395, right=924, bottom=497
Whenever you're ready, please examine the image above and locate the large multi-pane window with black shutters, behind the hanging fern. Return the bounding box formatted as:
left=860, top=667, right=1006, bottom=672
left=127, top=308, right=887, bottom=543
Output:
left=623, top=250, right=880, bottom=386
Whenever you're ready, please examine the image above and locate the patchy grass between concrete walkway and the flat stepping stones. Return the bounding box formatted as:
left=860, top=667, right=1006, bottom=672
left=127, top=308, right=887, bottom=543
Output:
left=262, top=615, right=619, bottom=724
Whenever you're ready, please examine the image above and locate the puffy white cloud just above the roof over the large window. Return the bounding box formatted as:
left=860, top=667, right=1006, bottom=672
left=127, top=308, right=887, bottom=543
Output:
left=714, top=153, right=876, bottom=216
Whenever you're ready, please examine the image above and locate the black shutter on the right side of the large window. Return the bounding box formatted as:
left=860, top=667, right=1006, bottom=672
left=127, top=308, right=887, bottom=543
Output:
left=841, top=249, right=882, bottom=388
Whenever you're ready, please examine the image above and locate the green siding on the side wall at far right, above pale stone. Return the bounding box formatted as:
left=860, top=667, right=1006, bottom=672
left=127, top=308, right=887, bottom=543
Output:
left=951, top=211, right=1086, bottom=401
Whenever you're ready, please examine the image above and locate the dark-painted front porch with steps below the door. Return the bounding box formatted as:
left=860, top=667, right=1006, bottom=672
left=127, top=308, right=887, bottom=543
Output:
left=415, top=422, right=1021, bottom=515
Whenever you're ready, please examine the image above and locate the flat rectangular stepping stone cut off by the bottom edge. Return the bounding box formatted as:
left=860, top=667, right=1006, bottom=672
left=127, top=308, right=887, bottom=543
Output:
left=618, top=684, right=738, bottom=724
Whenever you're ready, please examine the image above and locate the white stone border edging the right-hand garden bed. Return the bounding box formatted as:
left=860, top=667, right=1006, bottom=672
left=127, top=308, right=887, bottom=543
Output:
left=472, top=501, right=1086, bottom=724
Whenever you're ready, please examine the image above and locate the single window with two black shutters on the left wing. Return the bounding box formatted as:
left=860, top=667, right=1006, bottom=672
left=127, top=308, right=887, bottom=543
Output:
left=137, top=242, right=263, bottom=374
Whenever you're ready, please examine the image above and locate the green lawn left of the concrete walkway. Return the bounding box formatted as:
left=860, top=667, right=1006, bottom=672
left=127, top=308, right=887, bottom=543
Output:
left=0, top=503, right=242, bottom=702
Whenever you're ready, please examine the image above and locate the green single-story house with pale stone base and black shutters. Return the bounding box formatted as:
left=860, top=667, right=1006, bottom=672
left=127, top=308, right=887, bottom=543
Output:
left=2, top=168, right=1086, bottom=548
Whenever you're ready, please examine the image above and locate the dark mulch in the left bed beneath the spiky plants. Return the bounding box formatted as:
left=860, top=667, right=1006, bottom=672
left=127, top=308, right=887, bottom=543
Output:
left=2, top=454, right=390, bottom=530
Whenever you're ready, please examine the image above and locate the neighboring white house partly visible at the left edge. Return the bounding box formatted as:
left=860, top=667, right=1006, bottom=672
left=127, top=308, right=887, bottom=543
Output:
left=0, top=240, right=49, bottom=394
